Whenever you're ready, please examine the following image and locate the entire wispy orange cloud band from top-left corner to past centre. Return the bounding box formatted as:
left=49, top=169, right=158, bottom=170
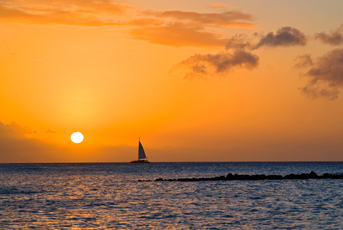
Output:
left=0, top=0, right=255, bottom=46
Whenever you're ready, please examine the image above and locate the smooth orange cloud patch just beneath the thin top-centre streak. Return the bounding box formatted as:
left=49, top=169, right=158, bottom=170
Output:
left=131, top=24, right=226, bottom=46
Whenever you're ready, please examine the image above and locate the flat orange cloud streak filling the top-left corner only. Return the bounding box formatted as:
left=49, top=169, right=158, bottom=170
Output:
left=0, top=0, right=132, bottom=26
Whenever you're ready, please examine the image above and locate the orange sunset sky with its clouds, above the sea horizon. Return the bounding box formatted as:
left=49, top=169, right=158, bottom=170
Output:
left=0, top=0, right=343, bottom=163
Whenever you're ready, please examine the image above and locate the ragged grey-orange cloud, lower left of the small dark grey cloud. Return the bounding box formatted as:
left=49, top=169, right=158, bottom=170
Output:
left=171, top=50, right=259, bottom=78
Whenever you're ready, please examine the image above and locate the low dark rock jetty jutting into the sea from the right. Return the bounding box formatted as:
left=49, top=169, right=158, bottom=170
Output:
left=155, top=171, right=343, bottom=181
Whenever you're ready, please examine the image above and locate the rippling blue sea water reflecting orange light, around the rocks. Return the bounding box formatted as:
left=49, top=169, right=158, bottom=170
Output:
left=0, top=162, right=343, bottom=229
